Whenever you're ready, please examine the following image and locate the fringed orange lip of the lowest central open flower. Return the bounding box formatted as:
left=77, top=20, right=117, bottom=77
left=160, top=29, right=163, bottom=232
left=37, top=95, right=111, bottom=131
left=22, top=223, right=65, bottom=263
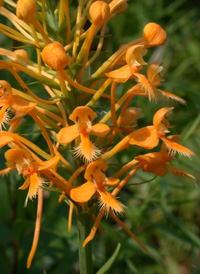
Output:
left=97, top=188, right=125, bottom=213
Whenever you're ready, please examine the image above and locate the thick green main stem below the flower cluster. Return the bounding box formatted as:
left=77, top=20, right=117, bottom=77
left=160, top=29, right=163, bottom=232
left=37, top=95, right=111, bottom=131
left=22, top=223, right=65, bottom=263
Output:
left=77, top=212, right=93, bottom=274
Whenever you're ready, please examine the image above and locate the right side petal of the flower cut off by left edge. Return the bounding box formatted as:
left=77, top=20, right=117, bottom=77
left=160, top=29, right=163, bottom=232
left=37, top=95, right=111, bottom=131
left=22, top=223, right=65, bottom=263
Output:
left=11, top=95, right=37, bottom=113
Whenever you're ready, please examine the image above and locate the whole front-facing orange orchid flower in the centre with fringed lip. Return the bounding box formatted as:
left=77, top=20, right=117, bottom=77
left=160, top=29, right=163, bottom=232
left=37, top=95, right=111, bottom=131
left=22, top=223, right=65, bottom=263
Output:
left=57, top=106, right=110, bottom=162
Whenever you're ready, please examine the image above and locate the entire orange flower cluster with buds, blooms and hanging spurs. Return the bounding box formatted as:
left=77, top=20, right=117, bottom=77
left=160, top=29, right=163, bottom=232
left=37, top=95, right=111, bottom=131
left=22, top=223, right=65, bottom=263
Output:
left=0, top=0, right=194, bottom=267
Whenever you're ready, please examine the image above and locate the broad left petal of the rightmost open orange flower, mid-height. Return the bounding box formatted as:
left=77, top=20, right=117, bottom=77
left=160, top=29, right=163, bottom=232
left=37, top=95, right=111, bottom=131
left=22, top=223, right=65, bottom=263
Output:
left=129, top=126, right=159, bottom=149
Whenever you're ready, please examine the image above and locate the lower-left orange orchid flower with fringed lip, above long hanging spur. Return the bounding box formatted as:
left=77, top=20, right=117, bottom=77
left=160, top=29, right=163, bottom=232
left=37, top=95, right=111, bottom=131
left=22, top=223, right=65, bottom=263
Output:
left=0, top=149, right=60, bottom=205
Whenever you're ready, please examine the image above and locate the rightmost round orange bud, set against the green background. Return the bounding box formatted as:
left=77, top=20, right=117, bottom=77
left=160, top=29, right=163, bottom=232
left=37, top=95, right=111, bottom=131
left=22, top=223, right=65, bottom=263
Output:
left=143, top=23, right=167, bottom=47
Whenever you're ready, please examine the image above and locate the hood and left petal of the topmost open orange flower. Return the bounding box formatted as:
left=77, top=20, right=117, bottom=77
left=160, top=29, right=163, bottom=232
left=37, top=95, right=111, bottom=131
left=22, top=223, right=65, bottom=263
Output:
left=105, top=45, right=147, bottom=83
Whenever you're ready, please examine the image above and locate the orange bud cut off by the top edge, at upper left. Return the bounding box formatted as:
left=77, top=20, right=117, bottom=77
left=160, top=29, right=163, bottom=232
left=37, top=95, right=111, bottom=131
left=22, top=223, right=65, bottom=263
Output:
left=16, top=0, right=37, bottom=23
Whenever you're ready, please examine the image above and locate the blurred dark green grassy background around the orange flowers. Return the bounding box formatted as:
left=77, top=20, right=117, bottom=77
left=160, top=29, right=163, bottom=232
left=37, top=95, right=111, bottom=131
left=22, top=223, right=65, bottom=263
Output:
left=0, top=0, right=200, bottom=274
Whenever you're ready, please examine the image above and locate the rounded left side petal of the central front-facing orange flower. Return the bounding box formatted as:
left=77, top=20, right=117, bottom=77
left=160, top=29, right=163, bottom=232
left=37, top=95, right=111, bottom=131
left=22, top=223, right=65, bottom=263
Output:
left=57, top=125, right=79, bottom=144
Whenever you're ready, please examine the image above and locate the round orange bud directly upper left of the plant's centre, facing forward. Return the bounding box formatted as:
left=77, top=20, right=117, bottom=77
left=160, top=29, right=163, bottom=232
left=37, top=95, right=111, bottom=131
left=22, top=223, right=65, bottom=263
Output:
left=42, top=41, right=69, bottom=71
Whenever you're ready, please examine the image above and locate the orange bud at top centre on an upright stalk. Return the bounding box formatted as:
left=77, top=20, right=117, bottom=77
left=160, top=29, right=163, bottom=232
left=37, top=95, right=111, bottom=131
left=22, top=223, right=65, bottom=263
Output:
left=89, top=1, right=110, bottom=26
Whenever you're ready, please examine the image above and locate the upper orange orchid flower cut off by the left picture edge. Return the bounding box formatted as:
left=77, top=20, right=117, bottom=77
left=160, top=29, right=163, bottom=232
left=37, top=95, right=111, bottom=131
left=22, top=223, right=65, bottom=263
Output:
left=0, top=80, right=37, bottom=131
